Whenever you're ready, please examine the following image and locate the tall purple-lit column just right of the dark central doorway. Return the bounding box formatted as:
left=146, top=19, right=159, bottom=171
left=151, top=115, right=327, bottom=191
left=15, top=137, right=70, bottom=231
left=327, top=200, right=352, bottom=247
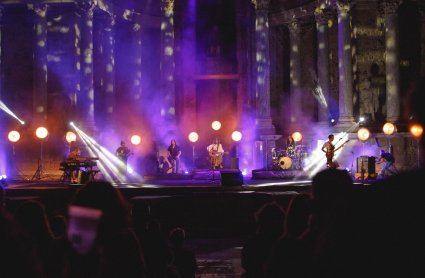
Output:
left=252, top=0, right=275, bottom=135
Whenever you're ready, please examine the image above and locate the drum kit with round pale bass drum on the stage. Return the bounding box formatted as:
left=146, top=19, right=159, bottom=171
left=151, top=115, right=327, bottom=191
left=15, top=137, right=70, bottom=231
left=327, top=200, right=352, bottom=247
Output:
left=269, top=145, right=309, bottom=170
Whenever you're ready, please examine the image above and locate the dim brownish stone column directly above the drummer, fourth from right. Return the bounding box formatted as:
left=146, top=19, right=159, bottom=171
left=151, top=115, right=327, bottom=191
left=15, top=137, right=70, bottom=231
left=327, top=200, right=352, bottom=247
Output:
left=287, top=19, right=302, bottom=124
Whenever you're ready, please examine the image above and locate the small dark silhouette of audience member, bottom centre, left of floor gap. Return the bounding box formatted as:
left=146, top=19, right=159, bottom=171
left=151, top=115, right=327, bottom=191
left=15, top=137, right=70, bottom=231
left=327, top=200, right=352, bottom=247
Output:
left=170, top=228, right=198, bottom=278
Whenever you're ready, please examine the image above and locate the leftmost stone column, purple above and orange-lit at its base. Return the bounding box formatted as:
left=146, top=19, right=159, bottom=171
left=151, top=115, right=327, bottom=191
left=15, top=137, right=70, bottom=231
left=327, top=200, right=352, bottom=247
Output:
left=28, top=4, right=48, bottom=126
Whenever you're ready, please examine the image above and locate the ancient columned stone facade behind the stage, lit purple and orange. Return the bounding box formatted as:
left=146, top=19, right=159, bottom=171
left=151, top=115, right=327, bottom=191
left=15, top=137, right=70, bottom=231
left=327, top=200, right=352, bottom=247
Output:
left=0, top=0, right=425, bottom=176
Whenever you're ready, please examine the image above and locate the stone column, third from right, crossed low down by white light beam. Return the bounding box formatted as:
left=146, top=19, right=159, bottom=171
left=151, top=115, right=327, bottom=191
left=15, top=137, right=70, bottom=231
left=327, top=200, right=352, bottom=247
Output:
left=314, top=9, right=332, bottom=126
